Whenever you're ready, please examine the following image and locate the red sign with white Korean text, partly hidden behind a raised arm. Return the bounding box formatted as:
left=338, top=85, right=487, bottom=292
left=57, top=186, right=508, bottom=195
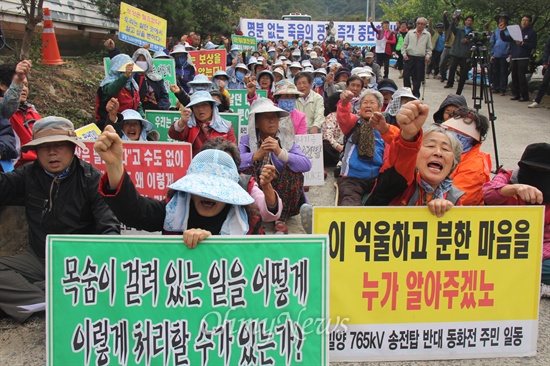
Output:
left=75, top=141, right=191, bottom=199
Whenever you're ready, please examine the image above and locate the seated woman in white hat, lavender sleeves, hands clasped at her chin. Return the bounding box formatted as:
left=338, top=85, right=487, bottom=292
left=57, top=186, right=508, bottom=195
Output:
left=239, top=98, right=311, bottom=234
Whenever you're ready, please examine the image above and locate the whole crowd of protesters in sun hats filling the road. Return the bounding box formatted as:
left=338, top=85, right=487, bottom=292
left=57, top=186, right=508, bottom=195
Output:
left=0, top=12, right=550, bottom=321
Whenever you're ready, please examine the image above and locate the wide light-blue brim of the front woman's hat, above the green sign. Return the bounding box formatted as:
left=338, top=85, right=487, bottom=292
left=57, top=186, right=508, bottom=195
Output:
left=168, top=169, right=254, bottom=206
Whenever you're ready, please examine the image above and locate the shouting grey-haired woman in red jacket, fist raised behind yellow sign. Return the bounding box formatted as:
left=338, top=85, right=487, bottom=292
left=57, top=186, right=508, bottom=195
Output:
left=366, top=101, right=464, bottom=217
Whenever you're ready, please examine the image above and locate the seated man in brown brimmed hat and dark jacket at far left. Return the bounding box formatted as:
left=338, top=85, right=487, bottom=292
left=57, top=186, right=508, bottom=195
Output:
left=0, top=117, right=120, bottom=323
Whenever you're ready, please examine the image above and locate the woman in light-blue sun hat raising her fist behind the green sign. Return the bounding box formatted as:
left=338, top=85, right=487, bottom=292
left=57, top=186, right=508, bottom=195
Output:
left=94, top=126, right=254, bottom=248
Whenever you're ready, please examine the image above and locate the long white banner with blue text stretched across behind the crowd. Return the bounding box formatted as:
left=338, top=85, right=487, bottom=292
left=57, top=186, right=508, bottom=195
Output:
left=240, top=18, right=397, bottom=46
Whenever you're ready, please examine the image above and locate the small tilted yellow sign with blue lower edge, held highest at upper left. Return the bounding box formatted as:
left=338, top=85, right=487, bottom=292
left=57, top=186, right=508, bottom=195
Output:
left=118, top=3, right=167, bottom=51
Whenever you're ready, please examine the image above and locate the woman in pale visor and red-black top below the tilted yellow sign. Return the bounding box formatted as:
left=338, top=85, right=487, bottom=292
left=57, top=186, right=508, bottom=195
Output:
left=96, top=53, right=144, bottom=130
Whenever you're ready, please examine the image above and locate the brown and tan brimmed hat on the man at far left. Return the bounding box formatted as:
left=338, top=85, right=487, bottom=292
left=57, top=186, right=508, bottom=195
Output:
left=21, top=116, right=86, bottom=152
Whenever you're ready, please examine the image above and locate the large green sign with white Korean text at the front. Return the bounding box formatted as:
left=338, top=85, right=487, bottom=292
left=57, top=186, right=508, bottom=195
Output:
left=46, top=235, right=330, bottom=365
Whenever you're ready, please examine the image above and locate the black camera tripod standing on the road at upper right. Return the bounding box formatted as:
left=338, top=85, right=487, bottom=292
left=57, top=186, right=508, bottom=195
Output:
left=470, top=38, right=501, bottom=174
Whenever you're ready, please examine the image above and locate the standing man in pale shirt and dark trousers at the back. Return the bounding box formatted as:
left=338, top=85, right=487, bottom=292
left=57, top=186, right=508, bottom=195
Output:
left=401, top=17, right=432, bottom=98
